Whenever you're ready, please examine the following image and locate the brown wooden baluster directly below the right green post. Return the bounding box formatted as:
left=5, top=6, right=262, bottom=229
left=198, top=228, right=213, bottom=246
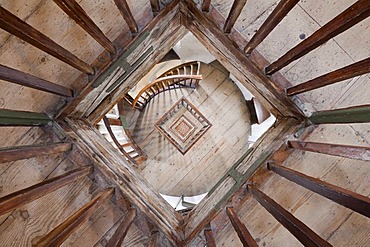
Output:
left=288, top=141, right=370, bottom=161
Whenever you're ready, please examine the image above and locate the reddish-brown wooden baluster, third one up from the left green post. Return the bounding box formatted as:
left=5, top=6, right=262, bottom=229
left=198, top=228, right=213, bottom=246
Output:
left=54, top=0, right=116, bottom=54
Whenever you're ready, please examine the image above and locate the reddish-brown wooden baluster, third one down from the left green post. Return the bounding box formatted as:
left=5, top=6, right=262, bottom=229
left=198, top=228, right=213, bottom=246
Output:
left=35, top=188, right=114, bottom=246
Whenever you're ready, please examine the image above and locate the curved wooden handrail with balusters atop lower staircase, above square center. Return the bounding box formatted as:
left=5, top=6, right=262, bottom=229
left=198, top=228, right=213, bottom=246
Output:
left=132, top=75, right=203, bottom=107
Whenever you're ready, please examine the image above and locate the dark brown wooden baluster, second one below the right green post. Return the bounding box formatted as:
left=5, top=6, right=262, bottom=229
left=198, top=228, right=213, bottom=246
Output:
left=268, top=164, right=370, bottom=218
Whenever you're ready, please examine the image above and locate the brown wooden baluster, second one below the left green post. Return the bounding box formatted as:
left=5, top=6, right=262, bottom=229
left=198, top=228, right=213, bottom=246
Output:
left=0, top=167, right=92, bottom=215
